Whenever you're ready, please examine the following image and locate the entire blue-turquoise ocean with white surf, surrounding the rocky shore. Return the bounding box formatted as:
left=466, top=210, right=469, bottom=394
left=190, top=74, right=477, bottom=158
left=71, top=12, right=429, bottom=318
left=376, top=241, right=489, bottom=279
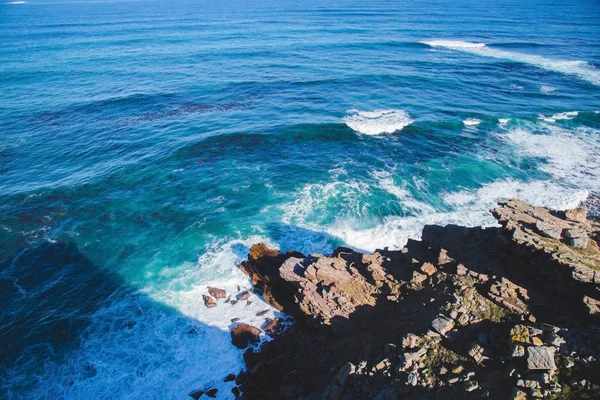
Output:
left=0, top=0, right=600, bottom=399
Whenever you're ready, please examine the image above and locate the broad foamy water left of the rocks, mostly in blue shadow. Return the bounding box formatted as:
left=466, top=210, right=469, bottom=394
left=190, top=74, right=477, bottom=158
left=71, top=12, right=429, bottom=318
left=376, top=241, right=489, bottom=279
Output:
left=3, top=236, right=286, bottom=400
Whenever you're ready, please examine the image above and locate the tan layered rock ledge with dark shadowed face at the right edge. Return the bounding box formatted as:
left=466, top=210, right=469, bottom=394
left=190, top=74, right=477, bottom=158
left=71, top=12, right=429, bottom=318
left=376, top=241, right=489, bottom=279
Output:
left=492, top=200, right=600, bottom=314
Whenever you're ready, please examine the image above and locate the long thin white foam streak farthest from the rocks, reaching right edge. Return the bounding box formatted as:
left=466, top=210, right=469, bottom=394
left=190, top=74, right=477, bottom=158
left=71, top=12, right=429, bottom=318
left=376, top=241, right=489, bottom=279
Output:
left=421, top=40, right=600, bottom=85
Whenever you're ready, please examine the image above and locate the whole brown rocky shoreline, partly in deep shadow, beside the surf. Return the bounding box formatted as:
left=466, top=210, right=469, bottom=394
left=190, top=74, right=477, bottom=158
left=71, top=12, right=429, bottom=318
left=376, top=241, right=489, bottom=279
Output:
left=193, top=200, right=600, bottom=399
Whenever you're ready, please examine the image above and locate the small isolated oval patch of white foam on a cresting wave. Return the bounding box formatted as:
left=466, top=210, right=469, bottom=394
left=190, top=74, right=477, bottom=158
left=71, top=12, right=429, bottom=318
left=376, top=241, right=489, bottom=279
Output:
left=342, top=110, right=413, bottom=135
